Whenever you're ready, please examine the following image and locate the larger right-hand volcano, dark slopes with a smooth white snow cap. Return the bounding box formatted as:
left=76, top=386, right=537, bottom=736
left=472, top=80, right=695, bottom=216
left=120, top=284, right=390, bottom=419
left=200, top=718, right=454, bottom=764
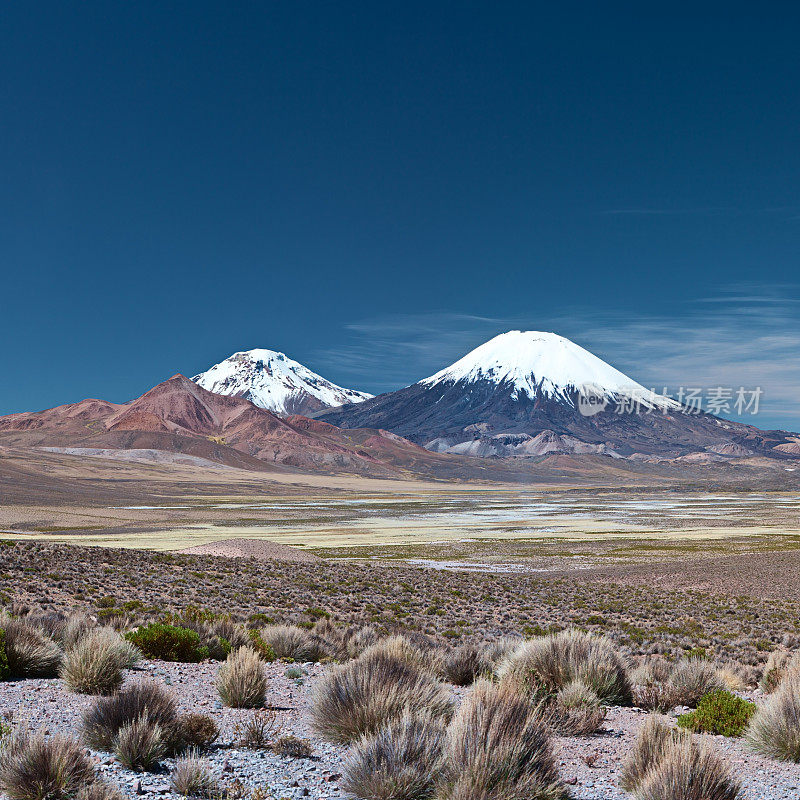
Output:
left=317, top=331, right=764, bottom=458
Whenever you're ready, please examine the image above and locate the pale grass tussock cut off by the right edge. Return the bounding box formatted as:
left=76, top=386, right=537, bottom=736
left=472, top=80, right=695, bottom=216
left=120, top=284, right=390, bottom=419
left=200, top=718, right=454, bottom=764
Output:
left=745, top=676, right=800, bottom=762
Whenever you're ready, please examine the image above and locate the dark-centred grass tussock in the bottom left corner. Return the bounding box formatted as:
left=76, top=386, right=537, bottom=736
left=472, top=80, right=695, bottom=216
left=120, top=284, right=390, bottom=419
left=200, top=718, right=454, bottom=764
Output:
left=0, top=732, right=94, bottom=800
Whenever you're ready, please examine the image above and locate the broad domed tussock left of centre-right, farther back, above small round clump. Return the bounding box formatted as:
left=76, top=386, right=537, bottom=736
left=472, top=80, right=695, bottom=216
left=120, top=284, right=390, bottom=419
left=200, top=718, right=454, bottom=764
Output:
left=498, top=630, right=631, bottom=703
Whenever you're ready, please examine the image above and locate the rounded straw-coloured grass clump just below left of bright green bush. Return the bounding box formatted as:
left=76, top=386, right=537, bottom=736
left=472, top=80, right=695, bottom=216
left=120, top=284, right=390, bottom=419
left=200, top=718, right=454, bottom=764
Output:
left=60, top=628, right=141, bottom=694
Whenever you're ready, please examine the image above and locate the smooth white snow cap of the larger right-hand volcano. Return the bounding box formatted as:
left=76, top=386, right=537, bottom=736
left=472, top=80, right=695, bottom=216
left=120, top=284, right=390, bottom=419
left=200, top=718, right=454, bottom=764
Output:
left=420, top=331, right=679, bottom=408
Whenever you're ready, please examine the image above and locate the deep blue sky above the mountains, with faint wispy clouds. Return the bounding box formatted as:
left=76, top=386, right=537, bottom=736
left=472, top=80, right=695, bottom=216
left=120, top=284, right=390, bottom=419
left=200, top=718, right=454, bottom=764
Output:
left=0, top=0, right=800, bottom=427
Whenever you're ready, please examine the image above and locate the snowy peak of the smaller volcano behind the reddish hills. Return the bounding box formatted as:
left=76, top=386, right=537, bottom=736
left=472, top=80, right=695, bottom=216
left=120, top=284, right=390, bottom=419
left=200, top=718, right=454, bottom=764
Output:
left=192, top=349, right=372, bottom=416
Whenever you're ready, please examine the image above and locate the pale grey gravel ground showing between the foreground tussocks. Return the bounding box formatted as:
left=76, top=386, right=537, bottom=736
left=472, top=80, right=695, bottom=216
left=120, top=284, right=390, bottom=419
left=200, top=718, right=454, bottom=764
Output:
left=0, top=662, right=800, bottom=800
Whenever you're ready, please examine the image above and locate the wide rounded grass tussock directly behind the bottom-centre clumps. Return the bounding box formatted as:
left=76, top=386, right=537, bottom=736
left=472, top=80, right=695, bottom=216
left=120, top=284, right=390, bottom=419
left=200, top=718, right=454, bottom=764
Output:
left=311, top=651, right=452, bottom=743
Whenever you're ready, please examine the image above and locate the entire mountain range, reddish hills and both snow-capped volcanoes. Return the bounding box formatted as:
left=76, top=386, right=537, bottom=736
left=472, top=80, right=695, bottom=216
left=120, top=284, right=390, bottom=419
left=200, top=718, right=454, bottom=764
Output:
left=0, top=331, right=800, bottom=480
